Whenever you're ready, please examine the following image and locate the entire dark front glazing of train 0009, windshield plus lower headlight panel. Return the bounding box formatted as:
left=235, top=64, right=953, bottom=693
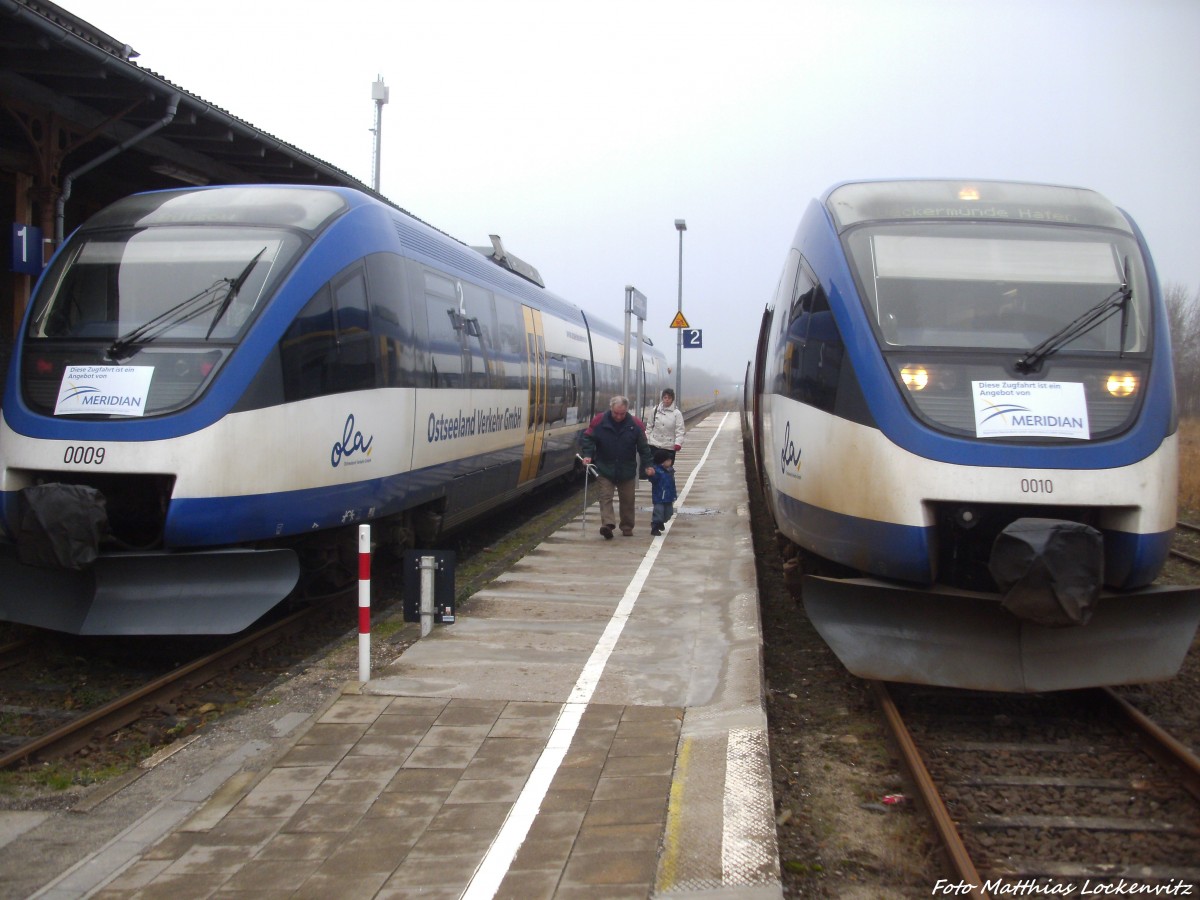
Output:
left=20, top=224, right=307, bottom=416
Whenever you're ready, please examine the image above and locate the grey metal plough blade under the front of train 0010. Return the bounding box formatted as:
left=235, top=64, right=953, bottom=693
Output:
left=800, top=575, right=1200, bottom=694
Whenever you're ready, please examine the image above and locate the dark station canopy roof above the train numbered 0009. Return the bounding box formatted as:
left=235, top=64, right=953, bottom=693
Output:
left=0, top=0, right=370, bottom=213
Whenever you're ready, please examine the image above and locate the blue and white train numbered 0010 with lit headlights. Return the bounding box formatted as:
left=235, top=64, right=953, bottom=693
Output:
left=748, top=180, right=1200, bottom=691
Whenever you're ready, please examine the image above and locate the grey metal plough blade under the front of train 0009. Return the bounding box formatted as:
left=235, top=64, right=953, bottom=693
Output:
left=0, top=544, right=300, bottom=635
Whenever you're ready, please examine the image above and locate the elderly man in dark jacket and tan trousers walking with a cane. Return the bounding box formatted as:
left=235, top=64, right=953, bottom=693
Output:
left=581, top=396, right=654, bottom=541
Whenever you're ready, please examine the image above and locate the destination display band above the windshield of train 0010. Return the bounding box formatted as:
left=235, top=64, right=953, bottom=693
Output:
left=822, top=179, right=1133, bottom=234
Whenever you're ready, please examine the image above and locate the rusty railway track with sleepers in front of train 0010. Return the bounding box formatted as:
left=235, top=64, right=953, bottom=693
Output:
left=872, top=682, right=1200, bottom=898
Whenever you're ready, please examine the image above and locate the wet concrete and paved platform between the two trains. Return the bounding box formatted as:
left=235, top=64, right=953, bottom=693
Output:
left=28, top=414, right=782, bottom=900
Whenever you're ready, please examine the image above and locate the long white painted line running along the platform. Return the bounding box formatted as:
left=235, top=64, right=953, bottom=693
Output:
left=462, top=413, right=730, bottom=900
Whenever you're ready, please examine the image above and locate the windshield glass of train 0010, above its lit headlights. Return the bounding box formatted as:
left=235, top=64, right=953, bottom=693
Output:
left=846, top=222, right=1150, bottom=353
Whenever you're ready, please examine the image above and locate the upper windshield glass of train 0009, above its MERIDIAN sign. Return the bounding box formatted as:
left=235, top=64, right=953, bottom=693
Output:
left=28, top=226, right=301, bottom=348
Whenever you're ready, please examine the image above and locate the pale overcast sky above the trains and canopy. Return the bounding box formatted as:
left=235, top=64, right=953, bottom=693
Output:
left=60, top=0, right=1200, bottom=394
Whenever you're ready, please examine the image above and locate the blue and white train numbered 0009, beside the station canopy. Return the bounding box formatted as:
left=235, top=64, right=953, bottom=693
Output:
left=0, top=186, right=667, bottom=634
